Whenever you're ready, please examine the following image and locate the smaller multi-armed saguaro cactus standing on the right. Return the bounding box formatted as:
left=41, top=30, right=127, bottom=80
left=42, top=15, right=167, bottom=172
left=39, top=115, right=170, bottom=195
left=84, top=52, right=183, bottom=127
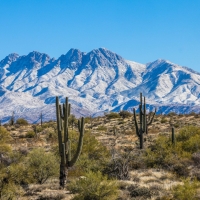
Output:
left=133, top=93, right=156, bottom=149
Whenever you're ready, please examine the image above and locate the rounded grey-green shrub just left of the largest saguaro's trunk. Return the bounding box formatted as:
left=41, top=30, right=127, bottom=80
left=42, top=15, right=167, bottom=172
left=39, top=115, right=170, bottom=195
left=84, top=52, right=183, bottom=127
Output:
left=26, top=149, right=59, bottom=184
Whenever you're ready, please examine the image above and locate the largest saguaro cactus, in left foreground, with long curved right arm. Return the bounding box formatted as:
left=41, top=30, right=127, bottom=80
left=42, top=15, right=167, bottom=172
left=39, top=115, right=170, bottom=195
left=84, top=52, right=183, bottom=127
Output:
left=56, top=97, right=84, bottom=187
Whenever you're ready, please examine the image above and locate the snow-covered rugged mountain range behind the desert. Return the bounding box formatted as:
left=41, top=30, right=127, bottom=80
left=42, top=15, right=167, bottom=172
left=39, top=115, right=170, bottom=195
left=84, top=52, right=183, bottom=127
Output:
left=0, top=48, right=200, bottom=122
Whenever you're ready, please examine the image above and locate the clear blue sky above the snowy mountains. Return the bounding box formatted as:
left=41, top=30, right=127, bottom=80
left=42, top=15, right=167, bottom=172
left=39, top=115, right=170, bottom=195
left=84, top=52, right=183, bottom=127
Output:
left=0, top=0, right=200, bottom=72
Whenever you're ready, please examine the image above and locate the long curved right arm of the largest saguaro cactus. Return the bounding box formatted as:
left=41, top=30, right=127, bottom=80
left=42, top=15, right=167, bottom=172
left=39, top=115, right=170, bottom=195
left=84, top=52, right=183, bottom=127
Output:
left=69, top=117, right=84, bottom=167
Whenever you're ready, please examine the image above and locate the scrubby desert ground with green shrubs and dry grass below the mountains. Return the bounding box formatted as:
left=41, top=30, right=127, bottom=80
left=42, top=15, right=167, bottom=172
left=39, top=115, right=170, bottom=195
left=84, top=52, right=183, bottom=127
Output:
left=0, top=108, right=200, bottom=200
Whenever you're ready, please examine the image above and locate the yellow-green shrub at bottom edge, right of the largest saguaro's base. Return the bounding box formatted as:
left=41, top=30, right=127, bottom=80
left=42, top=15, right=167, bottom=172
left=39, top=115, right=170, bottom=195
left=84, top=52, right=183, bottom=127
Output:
left=68, top=171, right=118, bottom=200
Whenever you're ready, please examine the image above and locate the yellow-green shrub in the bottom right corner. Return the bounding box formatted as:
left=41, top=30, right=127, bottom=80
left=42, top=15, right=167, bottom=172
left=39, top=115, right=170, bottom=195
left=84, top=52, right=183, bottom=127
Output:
left=173, top=179, right=200, bottom=200
